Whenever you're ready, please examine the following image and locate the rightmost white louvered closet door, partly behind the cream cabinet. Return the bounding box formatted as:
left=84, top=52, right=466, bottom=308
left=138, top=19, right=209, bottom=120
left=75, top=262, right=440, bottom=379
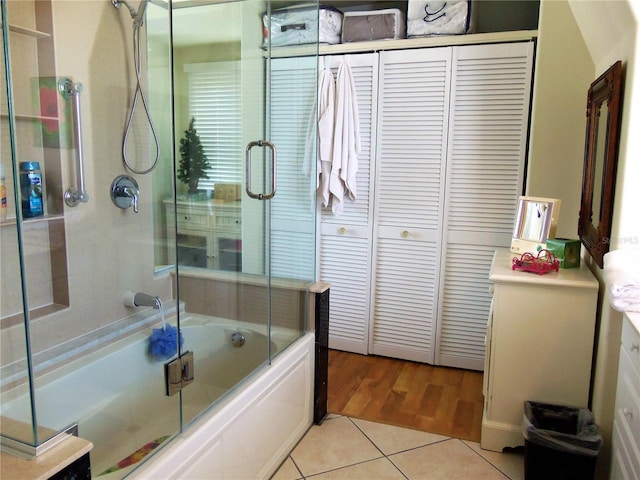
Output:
left=436, top=42, right=534, bottom=370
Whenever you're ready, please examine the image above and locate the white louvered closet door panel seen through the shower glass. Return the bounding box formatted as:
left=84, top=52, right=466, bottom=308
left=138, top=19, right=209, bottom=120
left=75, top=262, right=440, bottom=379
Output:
left=270, top=57, right=317, bottom=280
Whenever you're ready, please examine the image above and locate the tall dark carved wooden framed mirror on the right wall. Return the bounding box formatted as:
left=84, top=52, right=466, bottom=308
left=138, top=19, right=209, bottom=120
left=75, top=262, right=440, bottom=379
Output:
left=578, top=61, right=622, bottom=268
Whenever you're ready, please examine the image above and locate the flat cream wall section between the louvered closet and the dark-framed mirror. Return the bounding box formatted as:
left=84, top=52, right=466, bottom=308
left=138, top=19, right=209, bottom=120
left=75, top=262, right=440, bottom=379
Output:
left=526, top=1, right=595, bottom=238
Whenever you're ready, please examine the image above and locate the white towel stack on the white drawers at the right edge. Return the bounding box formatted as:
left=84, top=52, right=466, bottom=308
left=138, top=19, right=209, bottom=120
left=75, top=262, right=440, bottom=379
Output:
left=603, top=249, right=640, bottom=312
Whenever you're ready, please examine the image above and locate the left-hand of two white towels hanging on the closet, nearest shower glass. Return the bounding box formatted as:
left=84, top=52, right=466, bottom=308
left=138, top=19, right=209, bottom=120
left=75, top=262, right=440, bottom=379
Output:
left=318, top=61, right=336, bottom=207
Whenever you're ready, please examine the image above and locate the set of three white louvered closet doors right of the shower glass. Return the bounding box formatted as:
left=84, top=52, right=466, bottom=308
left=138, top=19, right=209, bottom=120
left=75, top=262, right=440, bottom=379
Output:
left=318, top=42, right=534, bottom=370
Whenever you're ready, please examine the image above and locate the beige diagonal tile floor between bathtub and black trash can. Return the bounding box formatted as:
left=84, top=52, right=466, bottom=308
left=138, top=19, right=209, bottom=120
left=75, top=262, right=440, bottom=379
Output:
left=272, top=415, right=524, bottom=480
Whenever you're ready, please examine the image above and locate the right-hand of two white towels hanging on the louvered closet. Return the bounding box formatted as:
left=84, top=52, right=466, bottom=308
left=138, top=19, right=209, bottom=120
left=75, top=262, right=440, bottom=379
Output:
left=329, top=61, right=360, bottom=215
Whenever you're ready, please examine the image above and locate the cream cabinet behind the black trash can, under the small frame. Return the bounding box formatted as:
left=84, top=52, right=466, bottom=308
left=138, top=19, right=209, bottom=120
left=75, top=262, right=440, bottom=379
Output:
left=480, top=249, right=599, bottom=452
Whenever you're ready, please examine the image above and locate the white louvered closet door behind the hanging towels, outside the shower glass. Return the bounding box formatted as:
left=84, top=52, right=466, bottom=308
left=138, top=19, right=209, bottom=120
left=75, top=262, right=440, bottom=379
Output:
left=318, top=53, right=378, bottom=354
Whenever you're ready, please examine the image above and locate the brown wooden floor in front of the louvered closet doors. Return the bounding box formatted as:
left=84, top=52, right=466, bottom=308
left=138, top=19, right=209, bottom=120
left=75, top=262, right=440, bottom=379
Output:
left=328, top=350, right=483, bottom=442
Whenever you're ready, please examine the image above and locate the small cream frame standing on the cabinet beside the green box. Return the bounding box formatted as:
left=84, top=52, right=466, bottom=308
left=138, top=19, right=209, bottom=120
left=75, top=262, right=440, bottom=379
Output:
left=511, top=197, right=560, bottom=253
